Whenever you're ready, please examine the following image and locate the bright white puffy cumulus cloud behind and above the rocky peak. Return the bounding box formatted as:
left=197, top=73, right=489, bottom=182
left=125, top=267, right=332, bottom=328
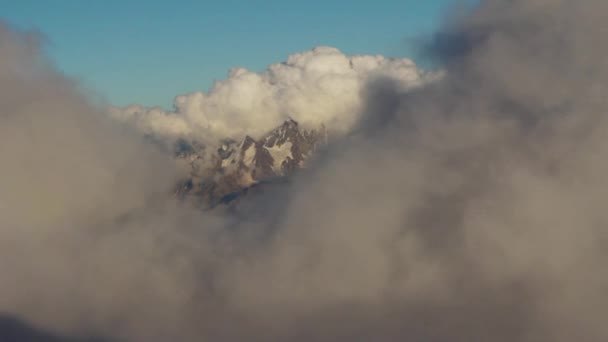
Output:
left=110, top=46, right=426, bottom=142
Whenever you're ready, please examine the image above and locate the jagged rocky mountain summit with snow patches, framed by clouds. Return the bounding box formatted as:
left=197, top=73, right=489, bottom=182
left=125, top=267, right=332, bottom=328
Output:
left=175, top=119, right=327, bottom=207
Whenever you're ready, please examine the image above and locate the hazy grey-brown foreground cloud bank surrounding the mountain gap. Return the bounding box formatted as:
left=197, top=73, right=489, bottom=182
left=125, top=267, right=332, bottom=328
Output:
left=0, top=0, right=608, bottom=342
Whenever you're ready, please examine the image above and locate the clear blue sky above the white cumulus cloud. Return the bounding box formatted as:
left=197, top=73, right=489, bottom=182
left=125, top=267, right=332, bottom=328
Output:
left=0, top=0, right=464, bottom=108
